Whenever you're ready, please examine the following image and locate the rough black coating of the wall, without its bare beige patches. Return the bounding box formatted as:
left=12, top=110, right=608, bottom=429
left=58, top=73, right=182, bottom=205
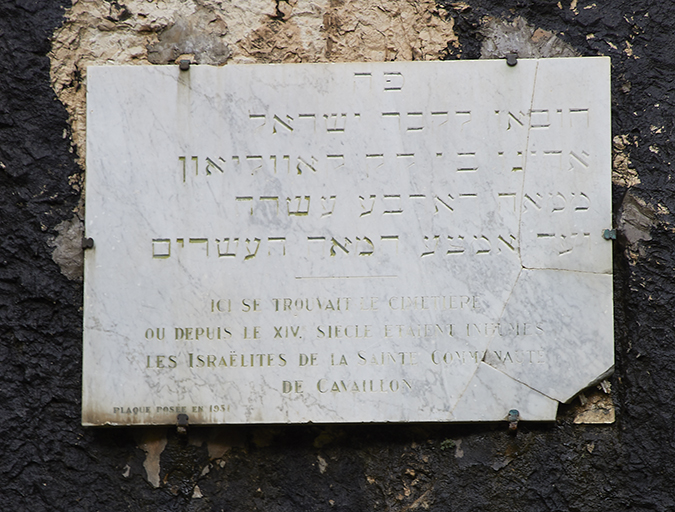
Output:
left=0, top=0, right=675, bottom=512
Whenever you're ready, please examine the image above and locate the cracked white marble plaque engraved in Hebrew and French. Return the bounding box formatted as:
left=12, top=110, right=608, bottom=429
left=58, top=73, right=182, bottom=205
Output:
left=82, top=57, right=614, bottom=425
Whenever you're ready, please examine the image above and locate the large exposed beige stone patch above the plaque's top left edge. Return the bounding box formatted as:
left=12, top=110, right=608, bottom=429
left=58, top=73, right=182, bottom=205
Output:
left=50, top=0, right=456, bottom=167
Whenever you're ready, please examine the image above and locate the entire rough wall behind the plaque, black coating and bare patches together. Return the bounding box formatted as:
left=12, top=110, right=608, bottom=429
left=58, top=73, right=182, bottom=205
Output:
left=0, top=0, right=675, bottom=512
